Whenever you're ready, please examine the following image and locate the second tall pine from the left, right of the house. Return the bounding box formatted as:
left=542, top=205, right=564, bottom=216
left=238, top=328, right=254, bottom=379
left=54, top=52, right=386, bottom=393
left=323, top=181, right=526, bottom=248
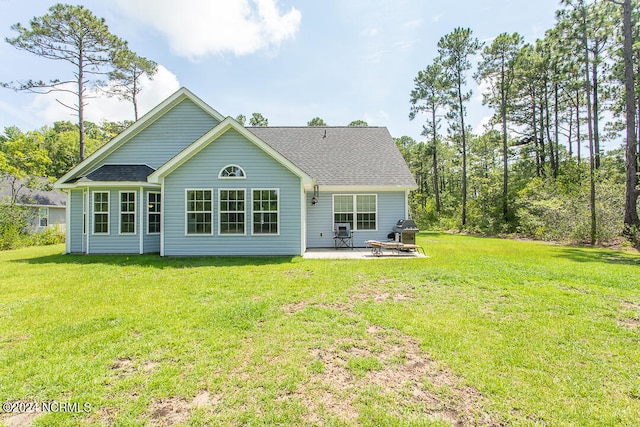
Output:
left=438, top=28, right=482, bottom=226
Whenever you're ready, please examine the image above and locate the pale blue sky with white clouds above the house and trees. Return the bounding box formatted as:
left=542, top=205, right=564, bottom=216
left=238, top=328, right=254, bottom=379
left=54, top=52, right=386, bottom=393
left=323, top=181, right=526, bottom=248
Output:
left=0, top=0, right=559, bottom=145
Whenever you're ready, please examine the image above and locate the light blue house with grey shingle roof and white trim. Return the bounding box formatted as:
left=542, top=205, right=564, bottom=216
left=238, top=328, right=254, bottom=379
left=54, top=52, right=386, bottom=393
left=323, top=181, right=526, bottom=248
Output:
left=55, top=88, right=415, bottom=256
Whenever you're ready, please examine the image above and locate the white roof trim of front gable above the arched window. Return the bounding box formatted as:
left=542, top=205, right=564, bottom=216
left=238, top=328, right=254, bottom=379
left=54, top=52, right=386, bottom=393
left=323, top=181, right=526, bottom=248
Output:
left=147, top=117, right=313, bottom=184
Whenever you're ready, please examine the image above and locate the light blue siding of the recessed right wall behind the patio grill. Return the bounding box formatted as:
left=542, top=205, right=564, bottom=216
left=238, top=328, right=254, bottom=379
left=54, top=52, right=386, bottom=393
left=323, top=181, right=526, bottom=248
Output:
left=307, top=191, right=406, bottom=248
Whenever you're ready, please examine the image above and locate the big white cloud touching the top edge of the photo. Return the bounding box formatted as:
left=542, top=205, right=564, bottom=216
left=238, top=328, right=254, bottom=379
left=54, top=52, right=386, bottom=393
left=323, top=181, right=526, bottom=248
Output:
left=117, top=0, right=302, bottom=60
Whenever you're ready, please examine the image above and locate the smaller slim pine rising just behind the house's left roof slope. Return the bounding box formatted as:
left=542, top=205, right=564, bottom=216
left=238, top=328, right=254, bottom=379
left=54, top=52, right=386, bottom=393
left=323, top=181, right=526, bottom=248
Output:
left=107, top=49, right=158, bottom=121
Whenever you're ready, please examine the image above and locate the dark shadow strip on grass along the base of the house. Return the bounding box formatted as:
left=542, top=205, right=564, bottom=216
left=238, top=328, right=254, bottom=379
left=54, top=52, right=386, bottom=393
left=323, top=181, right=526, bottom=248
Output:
left=11, top=254, right=302, bottom=269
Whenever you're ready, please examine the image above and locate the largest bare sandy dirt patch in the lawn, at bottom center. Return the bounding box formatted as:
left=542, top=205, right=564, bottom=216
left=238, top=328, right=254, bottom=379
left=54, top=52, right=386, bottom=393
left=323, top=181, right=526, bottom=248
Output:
left=296, top=316, right=500, bottom=426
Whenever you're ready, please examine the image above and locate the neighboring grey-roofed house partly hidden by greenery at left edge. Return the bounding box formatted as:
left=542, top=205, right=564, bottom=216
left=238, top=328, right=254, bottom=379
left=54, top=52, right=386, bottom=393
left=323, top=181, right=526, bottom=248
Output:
left=0, top=177, right=67, bottom=232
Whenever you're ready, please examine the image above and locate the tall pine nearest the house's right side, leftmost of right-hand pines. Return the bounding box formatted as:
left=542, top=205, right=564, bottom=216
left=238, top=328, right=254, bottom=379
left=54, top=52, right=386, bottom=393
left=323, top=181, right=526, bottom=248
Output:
left=409, top=61, right=450, bottom=214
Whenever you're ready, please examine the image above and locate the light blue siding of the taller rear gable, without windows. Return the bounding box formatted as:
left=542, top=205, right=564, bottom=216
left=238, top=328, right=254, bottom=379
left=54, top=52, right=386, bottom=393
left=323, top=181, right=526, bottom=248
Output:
left=98, top=99, right=218, bottom=169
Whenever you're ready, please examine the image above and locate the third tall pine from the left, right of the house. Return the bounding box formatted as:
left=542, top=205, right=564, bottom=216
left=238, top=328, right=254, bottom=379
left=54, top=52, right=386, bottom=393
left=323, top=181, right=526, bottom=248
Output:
left=477, top=33, right=524, bottom=223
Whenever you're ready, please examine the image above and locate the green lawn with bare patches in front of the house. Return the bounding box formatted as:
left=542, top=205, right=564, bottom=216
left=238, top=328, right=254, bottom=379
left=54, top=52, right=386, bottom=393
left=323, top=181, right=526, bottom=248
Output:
left=0, top=233, right=640, bottom=426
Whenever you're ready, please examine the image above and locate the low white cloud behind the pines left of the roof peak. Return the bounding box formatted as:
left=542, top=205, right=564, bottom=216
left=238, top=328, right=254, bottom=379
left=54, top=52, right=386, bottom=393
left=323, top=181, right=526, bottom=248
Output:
left=27, top=65, right=180, bottom=124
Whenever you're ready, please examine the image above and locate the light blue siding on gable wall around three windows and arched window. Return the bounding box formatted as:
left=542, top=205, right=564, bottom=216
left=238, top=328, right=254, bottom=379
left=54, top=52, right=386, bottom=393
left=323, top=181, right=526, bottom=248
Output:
left=163, top=130, right=302, bottom=256
